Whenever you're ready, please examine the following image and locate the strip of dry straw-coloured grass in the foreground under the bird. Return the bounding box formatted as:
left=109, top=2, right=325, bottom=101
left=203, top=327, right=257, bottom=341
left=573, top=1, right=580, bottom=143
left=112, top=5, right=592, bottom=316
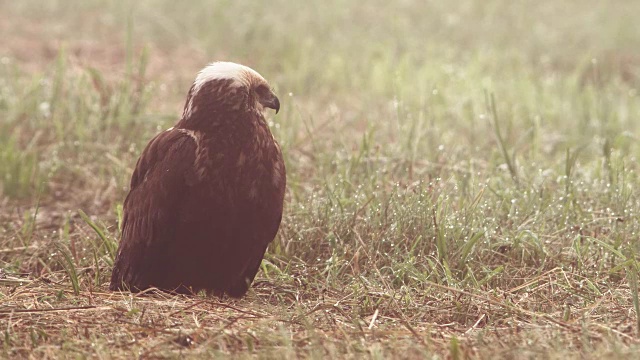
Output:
left=0, top=268, right=637, bottom=358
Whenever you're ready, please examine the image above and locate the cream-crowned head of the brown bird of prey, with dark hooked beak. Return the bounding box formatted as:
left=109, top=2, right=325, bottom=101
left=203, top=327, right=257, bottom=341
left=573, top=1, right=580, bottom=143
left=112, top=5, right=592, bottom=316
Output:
left=183, top=61, right=280, bottom=120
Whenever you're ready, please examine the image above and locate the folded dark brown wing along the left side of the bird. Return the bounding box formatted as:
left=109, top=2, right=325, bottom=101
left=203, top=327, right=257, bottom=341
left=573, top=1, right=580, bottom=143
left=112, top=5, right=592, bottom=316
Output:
left=111, top=129, right=197, bottom=291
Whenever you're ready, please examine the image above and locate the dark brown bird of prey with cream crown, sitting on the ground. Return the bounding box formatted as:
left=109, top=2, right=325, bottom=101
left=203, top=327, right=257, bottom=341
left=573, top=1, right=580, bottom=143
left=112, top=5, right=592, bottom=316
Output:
left=110, top=62, right=286, bottom=297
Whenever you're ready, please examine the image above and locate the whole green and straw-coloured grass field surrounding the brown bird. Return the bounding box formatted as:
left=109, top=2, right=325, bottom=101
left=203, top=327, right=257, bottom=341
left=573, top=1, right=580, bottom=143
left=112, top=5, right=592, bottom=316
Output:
left=0, top=0, right=640, bottom=359
